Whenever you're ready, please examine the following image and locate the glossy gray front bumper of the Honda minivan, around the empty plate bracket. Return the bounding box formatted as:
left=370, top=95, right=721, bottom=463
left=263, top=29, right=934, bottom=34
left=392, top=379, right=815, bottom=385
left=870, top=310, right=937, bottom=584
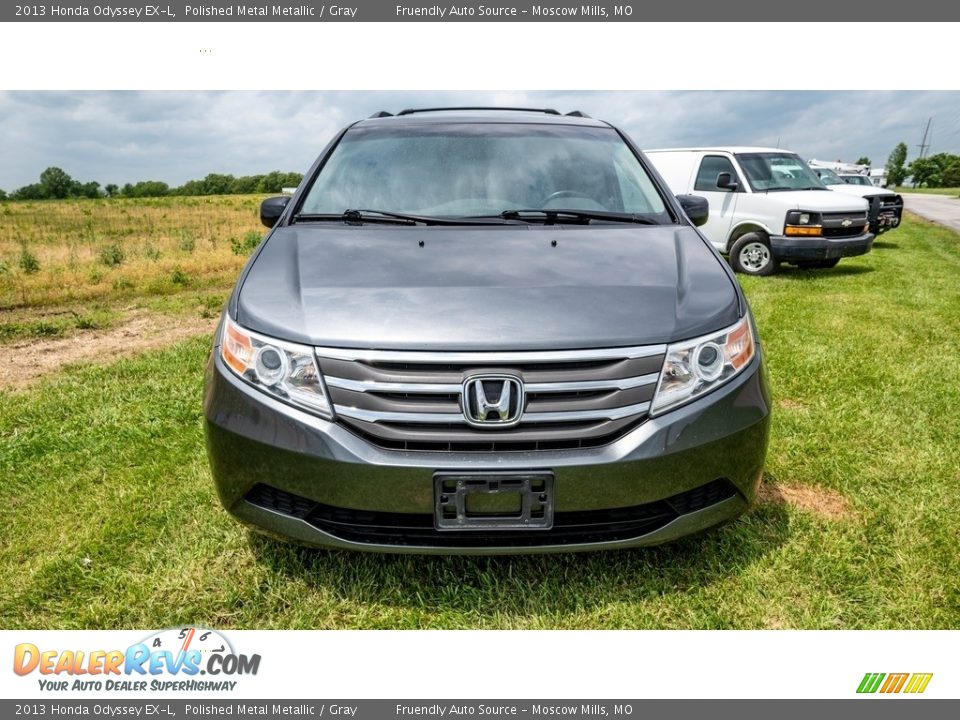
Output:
left=204, top=352, right=770, bottom=554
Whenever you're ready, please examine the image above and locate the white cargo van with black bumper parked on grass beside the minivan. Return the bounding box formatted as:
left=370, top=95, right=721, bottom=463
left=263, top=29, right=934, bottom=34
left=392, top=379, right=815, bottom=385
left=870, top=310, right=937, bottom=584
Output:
left=645, top=147, right=874, bottom=275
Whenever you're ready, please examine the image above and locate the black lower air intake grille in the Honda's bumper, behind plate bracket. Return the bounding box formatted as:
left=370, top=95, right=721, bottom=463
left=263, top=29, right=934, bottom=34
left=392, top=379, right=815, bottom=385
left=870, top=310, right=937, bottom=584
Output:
left=246, top=478, right=737, bottom=547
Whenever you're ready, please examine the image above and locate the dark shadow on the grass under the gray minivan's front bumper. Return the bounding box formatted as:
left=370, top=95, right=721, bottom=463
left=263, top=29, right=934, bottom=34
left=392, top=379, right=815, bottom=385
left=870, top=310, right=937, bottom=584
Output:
left=244, top=505, right=790, bottom=627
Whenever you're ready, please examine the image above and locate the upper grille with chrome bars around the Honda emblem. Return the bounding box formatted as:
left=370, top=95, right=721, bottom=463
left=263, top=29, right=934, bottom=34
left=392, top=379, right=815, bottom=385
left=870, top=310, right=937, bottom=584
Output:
left=316, top=345, right=666, bottom=452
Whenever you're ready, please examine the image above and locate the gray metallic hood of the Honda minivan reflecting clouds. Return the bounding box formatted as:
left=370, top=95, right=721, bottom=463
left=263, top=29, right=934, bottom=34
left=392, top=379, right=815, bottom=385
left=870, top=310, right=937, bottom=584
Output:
left=236, top=224, right=740, bottom=350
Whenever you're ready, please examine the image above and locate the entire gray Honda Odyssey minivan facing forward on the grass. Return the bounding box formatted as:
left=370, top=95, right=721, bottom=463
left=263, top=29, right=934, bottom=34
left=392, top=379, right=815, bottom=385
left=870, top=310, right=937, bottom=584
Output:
left=204, top=108, right=770, bottom=553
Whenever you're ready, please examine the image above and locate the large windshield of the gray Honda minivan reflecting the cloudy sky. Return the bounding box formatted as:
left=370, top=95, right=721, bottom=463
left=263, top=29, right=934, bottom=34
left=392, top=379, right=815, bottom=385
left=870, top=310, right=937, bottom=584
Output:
left=300, top=123, right=672, bottom=223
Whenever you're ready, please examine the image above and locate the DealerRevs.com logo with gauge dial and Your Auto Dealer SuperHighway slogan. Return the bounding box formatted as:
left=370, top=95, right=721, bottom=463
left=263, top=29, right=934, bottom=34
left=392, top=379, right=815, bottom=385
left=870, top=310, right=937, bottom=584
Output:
left=13, top=627, right=260, bottom=692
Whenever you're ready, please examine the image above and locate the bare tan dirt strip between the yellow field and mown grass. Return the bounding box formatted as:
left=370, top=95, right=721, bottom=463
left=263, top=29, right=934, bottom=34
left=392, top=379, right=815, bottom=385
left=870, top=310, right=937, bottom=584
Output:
left=0, top=310, right=217, bottom=390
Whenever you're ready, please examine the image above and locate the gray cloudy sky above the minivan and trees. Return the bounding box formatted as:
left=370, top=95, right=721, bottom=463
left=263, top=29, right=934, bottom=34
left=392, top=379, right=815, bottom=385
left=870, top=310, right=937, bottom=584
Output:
left=0, top=91, right=960, bottom=191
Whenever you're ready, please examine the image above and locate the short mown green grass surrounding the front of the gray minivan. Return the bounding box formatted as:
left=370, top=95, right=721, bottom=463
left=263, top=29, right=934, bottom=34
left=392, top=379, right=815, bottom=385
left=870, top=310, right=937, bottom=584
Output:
left=0, top=218, right=960, bottom=628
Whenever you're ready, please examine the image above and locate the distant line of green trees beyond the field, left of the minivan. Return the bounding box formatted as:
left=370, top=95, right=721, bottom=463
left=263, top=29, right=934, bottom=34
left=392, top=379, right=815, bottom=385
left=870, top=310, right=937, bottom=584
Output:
left=0, top=167, right=303, bottom=200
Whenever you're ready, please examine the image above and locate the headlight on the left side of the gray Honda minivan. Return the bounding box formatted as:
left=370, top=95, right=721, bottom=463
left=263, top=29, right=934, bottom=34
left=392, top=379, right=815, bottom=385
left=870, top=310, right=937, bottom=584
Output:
left=220, top=317, right=333, bottom=418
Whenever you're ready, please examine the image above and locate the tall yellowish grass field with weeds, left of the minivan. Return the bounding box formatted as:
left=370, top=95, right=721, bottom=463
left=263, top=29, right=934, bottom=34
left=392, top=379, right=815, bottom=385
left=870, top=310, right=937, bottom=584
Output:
left=0, top=195, right=265, bottom=343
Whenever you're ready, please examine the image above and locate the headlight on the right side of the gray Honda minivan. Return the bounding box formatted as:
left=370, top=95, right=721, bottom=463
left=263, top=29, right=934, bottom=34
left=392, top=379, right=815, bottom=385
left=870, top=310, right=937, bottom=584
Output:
left=650, top=317, right=755, bottom=415
